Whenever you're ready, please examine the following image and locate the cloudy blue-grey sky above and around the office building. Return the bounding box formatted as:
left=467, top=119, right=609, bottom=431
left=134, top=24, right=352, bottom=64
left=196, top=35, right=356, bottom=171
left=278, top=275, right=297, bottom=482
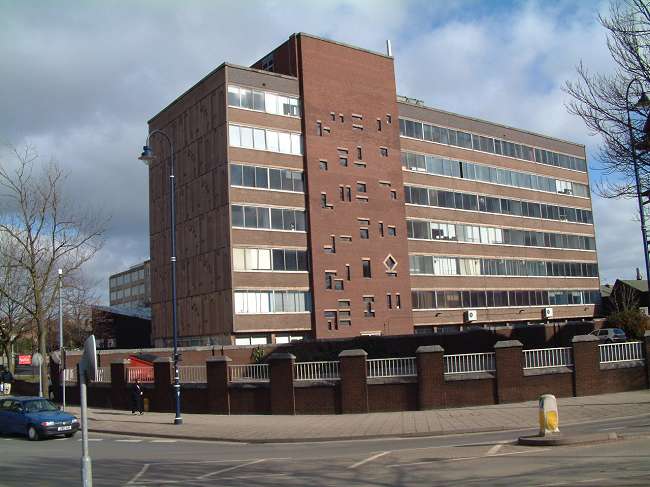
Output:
left=0, top=0, right=643, bottom=302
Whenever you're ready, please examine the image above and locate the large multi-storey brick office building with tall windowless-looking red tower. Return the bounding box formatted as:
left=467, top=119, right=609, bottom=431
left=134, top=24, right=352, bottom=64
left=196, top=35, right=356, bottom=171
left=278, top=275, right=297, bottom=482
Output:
left=149, top=34, right=599, bottom=345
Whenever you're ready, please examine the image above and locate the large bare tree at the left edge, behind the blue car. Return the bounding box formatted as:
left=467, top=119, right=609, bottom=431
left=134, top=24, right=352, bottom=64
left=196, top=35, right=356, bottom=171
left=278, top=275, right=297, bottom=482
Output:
left=0, top=146, right=106, bottom=383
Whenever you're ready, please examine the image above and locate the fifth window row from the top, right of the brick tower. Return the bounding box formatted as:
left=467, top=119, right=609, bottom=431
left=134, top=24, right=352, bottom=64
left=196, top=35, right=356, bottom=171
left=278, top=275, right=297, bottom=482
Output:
left=409, top=255, right=598, bottom=277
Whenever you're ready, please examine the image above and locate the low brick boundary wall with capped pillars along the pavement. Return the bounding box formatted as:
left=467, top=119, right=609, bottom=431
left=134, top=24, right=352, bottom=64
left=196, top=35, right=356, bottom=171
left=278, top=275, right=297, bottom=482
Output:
left=57, top=332, right=650, bottom=414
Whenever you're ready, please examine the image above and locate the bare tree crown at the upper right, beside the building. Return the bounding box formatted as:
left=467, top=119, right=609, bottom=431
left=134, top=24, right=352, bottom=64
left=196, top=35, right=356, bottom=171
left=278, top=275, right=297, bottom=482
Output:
left=564, top=0, right=650, bottom=198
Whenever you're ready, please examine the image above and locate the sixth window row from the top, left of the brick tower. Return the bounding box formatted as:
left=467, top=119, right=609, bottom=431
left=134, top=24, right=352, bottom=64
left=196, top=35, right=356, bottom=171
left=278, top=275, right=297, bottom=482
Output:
left=235, top=291, right=311, bottom=314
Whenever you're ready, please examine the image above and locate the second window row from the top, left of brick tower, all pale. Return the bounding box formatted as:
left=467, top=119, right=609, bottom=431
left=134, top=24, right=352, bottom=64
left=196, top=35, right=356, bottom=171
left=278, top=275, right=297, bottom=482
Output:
left=228, top=124, right=302, bottom=155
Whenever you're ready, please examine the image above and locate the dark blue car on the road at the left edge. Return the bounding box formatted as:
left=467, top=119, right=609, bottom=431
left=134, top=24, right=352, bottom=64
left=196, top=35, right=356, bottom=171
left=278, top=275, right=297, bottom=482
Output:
left=0, top=396, right=79, bottom=441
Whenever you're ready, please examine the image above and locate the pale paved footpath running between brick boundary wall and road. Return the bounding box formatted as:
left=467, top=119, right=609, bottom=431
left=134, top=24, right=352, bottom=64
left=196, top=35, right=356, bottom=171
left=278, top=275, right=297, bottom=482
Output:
left=63, top=390, right=650, bottom=442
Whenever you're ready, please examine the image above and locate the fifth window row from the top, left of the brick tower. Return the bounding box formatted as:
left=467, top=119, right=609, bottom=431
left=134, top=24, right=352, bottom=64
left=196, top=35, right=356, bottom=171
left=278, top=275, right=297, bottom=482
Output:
left=232, top=248, right=309, bottom=271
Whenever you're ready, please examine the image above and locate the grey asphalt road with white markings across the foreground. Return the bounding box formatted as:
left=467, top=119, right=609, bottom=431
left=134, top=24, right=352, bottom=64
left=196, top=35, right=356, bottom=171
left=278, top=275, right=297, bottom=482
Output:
left=0, top=416, right=650, bottom=487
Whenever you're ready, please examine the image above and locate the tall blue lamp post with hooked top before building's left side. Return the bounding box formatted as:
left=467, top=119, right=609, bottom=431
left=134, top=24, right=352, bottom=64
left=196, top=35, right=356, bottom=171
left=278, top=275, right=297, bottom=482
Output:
left=138, top=129, right=183, bottom=424
